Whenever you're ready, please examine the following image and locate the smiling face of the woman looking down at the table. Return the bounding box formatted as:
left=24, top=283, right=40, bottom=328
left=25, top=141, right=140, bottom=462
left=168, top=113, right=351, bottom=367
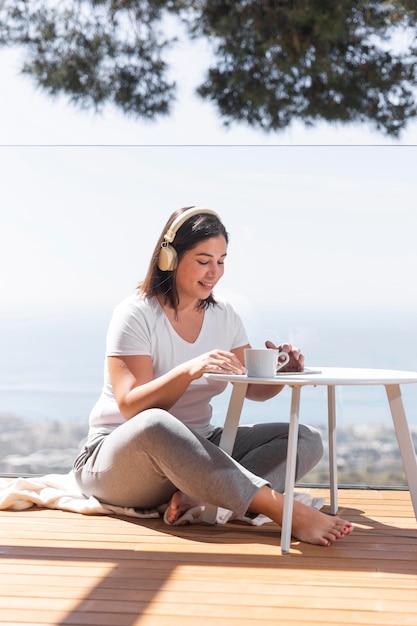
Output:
left=176, top=235, right=227, bottom=305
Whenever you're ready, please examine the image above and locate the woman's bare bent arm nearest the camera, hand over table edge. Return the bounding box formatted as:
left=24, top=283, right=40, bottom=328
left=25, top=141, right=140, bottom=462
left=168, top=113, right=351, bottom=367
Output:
left=107, top=350, right=245, bottom=419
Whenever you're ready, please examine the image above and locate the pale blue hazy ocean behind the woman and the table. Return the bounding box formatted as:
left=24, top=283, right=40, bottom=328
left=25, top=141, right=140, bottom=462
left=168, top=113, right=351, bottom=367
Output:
left=0, top=308, right=417, bottom=428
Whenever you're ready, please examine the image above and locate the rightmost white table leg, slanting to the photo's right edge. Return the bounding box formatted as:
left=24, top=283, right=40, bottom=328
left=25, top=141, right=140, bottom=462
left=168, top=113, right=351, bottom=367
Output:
left=385, top=385, right=417, bottom=518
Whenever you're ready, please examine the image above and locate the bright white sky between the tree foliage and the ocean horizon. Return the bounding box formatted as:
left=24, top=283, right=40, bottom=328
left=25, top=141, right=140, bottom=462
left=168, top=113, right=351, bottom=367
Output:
left=0, top=40, right=417, bottom=326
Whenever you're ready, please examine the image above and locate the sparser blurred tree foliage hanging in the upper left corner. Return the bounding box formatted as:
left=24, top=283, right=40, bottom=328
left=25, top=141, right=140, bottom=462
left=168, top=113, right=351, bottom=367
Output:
left=0, top=0, right=175, bottom=119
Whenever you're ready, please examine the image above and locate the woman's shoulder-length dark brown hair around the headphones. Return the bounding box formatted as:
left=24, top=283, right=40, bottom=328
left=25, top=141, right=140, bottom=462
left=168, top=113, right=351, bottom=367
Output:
left=138, top=207, right=229, bottom=312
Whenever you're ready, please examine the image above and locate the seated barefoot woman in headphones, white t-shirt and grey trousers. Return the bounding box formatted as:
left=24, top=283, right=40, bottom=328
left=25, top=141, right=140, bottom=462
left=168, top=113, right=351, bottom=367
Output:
left=74, top=207, right=352, bottom=545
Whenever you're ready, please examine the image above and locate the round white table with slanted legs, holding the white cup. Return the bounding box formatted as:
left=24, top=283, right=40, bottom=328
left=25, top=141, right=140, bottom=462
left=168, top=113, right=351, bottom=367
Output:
left=203, top=366, right=417, bottom=554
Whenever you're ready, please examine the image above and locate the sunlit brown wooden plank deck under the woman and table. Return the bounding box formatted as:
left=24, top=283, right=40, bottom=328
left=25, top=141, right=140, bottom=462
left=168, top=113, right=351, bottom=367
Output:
left=0, top=489, right=417, bottom=626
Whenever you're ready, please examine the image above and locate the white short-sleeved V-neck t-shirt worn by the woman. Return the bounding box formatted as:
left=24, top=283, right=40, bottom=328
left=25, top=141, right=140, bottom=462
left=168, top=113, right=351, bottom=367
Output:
left=90, top=294, right=248, bottom=437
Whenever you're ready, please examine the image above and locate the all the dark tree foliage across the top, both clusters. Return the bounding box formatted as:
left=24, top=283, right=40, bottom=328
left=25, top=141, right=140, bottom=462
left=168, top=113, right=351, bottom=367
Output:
left=0, top=0, right=417, bottom=136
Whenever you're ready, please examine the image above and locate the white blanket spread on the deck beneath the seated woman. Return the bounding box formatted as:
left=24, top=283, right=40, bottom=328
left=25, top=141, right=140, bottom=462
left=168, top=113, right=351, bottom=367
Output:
left=0, top=472, right=324, bottom=526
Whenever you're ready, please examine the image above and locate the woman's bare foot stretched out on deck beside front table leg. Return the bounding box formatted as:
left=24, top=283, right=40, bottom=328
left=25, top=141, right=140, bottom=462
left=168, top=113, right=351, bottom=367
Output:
left=292, top=500, right=353, bottom=546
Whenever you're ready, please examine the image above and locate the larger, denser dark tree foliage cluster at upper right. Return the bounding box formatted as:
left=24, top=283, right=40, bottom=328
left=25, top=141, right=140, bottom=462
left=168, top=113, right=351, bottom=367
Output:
left=194, top=0, right=417, bottom=135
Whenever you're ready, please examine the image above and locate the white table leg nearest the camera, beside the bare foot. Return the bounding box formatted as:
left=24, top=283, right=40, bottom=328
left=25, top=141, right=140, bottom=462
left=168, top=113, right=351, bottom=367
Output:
left=281, top=385, right=301, bottom=554
